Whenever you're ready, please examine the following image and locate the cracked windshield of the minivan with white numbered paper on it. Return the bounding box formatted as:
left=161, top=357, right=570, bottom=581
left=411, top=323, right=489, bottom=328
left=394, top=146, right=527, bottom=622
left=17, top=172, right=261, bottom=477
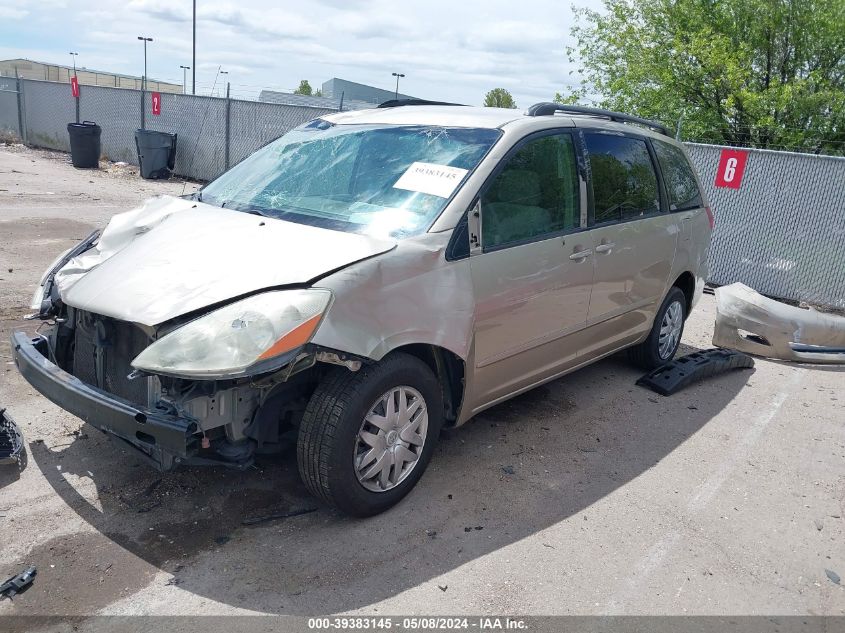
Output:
left=199, top=120, right=501, bottom=238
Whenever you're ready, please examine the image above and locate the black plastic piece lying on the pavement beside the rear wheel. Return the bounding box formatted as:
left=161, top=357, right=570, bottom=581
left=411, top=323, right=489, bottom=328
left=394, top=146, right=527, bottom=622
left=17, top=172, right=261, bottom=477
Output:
left=637, top=349, right=754, bottom=400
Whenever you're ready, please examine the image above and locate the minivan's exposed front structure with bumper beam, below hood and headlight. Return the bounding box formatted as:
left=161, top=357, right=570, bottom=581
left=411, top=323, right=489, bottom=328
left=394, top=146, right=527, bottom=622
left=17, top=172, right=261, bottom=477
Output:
left=12, top=306, right=362, bottom=470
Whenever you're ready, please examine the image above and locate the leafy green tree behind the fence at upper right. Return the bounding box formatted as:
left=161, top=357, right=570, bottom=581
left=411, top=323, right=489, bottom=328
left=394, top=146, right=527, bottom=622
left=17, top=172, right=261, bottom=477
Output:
left=556, top=0, right=845, bottom=152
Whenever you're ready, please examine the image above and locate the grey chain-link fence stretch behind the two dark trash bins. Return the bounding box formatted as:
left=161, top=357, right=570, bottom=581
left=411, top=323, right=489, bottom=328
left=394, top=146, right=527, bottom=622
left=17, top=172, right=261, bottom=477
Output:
left=0, top=77, right=334, bottom=180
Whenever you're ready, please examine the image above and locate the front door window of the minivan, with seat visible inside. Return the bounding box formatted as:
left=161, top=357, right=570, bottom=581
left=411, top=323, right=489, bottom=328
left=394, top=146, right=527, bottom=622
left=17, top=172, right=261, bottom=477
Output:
left=481, top=134, right=581, bottom=248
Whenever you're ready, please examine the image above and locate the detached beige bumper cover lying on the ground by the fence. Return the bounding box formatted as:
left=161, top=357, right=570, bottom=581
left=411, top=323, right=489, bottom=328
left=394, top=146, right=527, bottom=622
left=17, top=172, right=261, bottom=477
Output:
left=713, top=283, right=845, bottom=363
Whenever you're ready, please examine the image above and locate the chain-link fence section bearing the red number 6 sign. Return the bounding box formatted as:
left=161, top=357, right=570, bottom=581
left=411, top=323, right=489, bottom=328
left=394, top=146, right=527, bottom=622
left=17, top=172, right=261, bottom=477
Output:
left=687, top=143, right=845, bottom=308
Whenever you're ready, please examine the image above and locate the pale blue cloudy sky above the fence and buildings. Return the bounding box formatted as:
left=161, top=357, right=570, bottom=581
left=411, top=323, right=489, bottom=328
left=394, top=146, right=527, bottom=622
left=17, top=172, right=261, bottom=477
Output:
left=0, top=0, right=601, bottom=108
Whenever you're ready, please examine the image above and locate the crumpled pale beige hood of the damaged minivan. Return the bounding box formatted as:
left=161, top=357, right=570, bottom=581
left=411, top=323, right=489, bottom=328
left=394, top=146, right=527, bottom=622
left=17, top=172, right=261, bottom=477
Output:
left=56, top=197, right=396, bottom=326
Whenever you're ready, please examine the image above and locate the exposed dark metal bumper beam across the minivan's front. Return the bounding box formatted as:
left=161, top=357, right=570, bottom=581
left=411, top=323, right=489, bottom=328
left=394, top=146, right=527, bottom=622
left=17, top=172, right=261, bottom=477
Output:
left=11, top=332, right=197, bottom=470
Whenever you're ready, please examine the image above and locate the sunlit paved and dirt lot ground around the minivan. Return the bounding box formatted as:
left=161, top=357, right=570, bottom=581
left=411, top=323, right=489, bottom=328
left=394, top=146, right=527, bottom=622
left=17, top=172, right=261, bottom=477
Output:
left=0, top=142, right=845, bottom=615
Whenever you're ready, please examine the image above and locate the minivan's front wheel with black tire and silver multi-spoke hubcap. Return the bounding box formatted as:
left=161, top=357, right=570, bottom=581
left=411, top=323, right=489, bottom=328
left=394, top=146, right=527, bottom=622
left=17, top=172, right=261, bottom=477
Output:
left=297, top=352, right=443, bottom=517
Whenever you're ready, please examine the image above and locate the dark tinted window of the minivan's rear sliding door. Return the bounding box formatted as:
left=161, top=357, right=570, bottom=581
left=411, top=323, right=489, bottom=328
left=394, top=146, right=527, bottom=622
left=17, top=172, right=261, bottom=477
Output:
left=584, top=132, right=660, bottom=224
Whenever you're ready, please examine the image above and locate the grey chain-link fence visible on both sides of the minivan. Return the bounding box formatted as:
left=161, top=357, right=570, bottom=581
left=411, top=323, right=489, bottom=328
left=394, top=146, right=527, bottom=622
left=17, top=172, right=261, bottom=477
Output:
left=0, top=77, right=845, bottom=308
